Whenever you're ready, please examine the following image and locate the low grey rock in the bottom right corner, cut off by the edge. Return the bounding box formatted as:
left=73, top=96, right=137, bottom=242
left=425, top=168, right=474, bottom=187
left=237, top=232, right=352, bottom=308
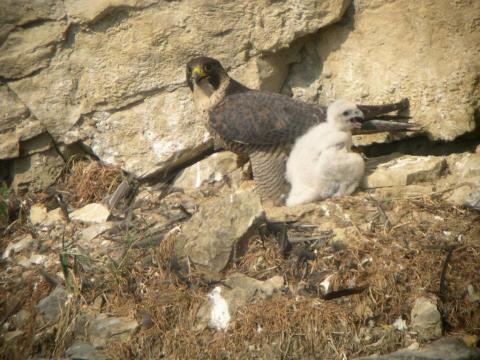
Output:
left=357, top=337, right=480, bottom=360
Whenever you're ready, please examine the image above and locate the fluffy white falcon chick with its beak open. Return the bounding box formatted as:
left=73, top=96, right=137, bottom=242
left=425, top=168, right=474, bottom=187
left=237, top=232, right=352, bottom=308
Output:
left=286, top=100, right=365, bottom=206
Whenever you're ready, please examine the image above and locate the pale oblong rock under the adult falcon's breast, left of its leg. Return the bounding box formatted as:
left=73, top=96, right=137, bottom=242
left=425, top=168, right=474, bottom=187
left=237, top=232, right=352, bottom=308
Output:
left=173, top=151, right=237, bottom=189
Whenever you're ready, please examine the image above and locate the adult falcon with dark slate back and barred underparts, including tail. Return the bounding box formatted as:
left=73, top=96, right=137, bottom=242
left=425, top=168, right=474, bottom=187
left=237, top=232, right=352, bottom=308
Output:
left=186, top=57, right=410, bottom=204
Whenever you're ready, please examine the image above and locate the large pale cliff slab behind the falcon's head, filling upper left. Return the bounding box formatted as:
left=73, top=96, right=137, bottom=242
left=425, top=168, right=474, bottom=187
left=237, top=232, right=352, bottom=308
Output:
left=0, top=0, right=350, bottom=177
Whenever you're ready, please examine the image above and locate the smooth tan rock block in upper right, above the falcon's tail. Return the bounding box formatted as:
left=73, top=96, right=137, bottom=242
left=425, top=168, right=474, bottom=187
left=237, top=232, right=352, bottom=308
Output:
left=284, top=0, right=480, bottom=140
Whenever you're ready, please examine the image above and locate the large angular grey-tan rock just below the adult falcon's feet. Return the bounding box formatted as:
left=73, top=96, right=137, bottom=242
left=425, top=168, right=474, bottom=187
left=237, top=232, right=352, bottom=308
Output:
left=175, top=191, right=264, bottom=272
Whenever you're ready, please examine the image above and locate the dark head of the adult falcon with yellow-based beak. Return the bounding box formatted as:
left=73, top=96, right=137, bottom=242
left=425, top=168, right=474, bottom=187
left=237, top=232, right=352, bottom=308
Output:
left=187, top=56, right=228, bottom=96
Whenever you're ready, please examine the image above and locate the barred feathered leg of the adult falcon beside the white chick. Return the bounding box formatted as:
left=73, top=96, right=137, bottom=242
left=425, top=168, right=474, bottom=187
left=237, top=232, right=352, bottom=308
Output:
left=250, top=146, right=289, bottom=205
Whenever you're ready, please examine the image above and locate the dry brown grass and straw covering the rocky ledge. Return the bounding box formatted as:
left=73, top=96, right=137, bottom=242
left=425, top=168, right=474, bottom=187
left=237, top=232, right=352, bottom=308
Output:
left=0, top=169, right=480, bottom=359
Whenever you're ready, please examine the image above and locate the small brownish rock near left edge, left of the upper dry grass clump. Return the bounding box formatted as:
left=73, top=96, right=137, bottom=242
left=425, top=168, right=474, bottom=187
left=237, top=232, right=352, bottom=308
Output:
left=10, top=149, right=65, bottom=192
